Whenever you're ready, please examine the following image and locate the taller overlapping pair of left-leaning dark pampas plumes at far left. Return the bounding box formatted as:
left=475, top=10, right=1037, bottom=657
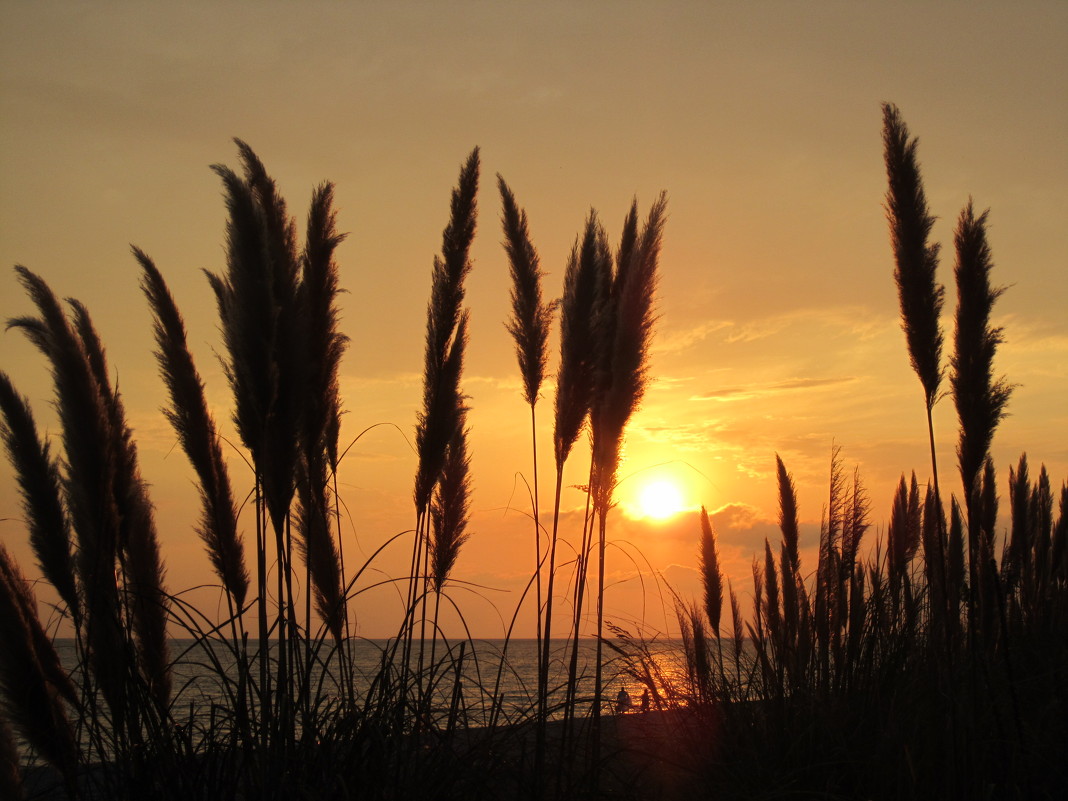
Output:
left=5, top=267, right=171, bottom=753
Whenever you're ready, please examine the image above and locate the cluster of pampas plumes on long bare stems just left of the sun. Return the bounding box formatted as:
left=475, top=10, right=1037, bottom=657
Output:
left=476, top=190, right=666, bottom=795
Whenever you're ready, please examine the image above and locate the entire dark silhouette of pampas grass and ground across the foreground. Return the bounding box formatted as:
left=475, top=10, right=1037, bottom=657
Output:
left=0, top=110, right=1068, bottom=799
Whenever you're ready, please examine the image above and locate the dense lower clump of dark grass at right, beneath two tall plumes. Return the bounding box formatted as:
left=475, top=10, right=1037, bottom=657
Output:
left=657, top=442, right=1068, bottom=799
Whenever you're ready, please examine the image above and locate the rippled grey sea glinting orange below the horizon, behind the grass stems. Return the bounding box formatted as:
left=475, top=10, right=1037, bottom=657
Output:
left=16, top=638, right=685, bottom=767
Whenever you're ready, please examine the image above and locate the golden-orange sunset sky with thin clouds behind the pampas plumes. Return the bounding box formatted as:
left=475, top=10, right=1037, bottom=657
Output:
left=0, top=0, right=1068, bottom=637
